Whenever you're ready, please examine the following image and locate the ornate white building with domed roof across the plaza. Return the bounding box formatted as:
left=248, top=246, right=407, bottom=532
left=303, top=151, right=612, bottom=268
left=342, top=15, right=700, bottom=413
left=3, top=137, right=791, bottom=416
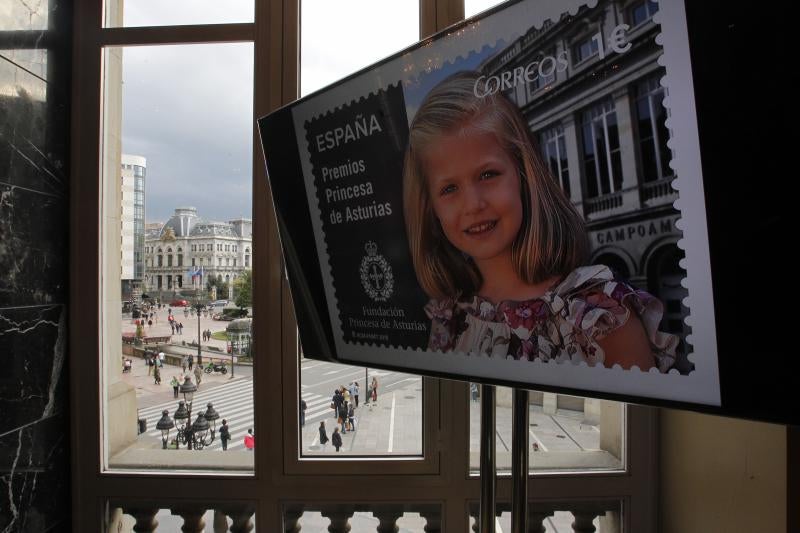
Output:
left=144, top=207, right=253, bottom=298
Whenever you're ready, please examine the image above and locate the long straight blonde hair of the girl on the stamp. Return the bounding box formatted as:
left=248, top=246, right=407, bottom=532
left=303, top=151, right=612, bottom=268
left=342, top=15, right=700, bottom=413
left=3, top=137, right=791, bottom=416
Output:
left=403, top=72, right=588, bottom=299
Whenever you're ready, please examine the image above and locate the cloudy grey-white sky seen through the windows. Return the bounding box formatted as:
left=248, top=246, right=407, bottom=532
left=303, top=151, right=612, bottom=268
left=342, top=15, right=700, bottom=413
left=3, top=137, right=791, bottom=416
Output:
left=122, top=0, right=496, bottom=222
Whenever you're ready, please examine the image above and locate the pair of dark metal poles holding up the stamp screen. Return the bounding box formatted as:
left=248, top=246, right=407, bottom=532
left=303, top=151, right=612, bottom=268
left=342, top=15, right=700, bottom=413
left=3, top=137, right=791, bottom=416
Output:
left=478, top=385, right=529, bottom=533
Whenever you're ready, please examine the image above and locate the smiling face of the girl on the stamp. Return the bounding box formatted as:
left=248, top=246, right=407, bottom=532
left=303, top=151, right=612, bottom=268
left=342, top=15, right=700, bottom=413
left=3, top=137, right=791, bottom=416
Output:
left=423, top=124, right=522, bottom=275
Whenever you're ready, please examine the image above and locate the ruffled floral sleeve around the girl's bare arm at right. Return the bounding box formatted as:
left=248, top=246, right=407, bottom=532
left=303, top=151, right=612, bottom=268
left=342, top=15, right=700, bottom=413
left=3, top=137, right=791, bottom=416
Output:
left=555, top=265, right=679, bottom=372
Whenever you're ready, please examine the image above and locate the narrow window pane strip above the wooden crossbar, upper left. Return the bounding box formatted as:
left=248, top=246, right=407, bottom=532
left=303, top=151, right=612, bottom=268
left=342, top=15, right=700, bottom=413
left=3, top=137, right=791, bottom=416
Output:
left=105, top=0, right=254, bottom=28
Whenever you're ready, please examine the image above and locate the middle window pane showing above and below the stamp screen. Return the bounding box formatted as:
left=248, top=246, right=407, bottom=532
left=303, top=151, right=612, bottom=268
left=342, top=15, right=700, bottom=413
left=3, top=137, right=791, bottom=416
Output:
left=299, top=0, right=422, bottom=456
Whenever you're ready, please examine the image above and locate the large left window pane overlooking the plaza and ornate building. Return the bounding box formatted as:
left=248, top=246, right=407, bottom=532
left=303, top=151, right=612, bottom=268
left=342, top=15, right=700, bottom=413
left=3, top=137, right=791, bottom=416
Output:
left=102, top=43, right=255, bottom=471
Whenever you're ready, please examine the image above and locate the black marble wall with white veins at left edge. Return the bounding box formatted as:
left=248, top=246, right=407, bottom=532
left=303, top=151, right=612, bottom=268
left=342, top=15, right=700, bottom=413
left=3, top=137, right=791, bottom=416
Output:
left=0, top=0, right=72, bottom=532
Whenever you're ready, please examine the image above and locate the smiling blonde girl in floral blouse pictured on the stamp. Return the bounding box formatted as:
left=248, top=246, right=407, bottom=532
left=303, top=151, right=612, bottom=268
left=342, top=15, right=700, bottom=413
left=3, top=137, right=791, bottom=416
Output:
left=403, top=72, right=678, bottom=372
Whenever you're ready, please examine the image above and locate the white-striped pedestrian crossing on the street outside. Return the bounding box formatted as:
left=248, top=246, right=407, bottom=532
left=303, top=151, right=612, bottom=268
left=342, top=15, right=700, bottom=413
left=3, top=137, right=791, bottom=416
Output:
left=139, top=376, right=333, bottom=450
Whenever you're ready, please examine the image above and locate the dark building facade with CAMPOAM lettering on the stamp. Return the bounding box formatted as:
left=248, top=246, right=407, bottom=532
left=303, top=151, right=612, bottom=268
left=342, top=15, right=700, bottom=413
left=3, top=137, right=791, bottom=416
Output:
left=476, top=0, right=689, bottom=366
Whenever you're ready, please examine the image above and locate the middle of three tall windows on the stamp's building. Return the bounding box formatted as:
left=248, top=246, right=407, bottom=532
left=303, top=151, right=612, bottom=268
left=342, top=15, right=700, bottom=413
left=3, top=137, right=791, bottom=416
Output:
left=581, top=98, right=622, bottom=198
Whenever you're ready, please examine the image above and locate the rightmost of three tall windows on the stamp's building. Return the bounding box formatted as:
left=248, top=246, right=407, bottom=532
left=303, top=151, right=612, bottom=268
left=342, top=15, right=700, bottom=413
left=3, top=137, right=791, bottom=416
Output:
left=636, top=73, right=672, bottom=182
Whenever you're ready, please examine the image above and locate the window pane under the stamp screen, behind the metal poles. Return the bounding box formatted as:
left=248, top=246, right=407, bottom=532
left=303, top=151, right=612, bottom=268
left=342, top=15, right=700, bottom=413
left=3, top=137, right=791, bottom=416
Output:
left=469, top=384, right=625, bottom=474
